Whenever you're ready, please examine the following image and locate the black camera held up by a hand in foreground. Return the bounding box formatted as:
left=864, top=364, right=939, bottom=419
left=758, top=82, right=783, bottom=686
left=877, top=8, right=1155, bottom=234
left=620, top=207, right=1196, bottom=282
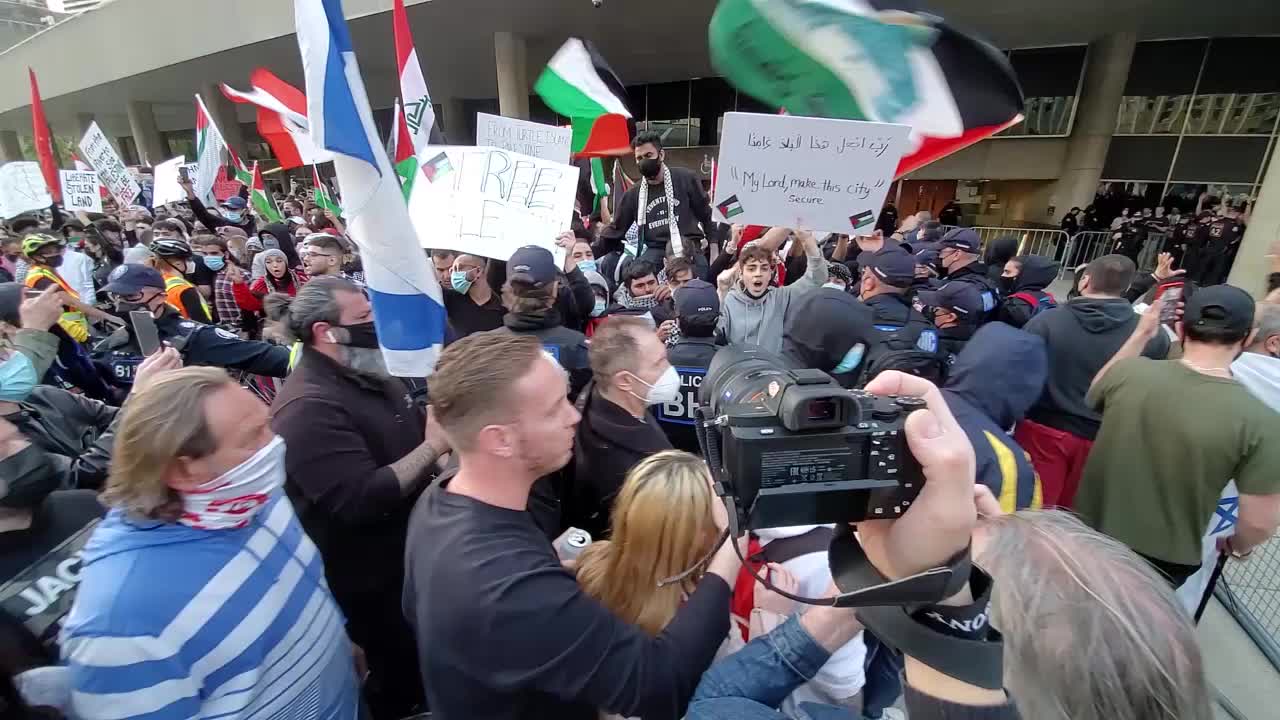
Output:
left=698, top=346, right=924, bottom=529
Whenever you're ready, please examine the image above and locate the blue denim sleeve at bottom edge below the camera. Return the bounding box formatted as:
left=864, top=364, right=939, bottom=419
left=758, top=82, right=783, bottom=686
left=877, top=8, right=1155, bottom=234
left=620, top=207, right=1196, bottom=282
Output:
left=685, top=615, right=854, bottom=720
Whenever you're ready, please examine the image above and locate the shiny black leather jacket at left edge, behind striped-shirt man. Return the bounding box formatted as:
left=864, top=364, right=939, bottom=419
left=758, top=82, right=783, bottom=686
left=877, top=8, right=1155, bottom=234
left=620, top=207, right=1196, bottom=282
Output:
left=5, top=386, right=119, bottom=489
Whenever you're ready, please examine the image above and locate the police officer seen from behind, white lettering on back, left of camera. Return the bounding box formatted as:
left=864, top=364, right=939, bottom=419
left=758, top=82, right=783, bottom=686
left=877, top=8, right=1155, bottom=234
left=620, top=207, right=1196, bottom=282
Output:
left=655, top=279, right=721, bottom=454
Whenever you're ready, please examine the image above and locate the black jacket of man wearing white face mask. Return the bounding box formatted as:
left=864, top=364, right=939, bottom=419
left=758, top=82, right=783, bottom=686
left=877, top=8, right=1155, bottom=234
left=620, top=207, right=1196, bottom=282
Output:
left=563, top=383, right=671, bottom=539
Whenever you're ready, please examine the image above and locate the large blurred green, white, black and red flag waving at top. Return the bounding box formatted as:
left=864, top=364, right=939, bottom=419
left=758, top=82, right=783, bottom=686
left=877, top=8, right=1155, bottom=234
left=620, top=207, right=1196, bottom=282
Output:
left=708, top=0, right=1023, bottom=177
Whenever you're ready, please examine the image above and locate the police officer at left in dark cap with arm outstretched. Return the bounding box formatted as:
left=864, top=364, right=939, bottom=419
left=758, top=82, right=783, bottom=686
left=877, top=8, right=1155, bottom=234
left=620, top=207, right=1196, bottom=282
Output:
left=104, top=264, right=289, bottom=386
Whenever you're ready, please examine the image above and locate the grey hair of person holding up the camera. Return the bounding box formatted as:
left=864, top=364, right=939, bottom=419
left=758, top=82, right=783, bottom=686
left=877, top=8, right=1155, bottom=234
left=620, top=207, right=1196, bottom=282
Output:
left=978, top=510, right=1212, bottom=720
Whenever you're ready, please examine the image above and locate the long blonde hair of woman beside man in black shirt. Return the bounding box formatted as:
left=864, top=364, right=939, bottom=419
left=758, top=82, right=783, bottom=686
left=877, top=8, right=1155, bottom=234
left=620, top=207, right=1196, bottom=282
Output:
left=577, top=450, right=718, bottom=635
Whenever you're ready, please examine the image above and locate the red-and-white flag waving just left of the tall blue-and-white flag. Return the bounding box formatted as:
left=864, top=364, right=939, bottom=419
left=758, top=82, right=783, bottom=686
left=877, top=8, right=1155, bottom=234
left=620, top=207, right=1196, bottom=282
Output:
left=221, top=68, right=333, bottom=170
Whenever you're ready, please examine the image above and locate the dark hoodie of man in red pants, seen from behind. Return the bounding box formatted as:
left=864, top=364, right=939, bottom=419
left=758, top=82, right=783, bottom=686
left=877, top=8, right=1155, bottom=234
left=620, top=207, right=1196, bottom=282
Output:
left=1024, top=297, right=1169, bottom=439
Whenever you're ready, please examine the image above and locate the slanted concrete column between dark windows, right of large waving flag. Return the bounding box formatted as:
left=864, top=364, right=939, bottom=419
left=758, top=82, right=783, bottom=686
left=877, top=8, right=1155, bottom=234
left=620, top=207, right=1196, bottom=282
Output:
left=1051, top=32, right=1138, bottom=214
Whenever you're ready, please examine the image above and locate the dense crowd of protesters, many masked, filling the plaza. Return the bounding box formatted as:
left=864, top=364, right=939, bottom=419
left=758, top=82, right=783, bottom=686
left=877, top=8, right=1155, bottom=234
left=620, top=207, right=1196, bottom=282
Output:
left=0, top=109, right=1280, bottom=720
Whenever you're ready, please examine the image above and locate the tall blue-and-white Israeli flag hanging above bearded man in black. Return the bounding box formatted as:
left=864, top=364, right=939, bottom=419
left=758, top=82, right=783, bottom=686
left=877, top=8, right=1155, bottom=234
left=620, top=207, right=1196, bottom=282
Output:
left=293, top=0, right=445, bottom=378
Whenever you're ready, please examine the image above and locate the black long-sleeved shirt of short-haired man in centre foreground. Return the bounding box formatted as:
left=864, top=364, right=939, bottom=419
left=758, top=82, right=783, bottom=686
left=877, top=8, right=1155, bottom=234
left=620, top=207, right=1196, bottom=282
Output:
left=403, top=476, right=730, bottom=720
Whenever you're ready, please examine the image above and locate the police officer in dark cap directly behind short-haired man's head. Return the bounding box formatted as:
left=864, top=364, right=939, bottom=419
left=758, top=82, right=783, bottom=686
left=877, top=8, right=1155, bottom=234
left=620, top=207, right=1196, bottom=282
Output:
left=490, top=245, right=591, bottom=400
